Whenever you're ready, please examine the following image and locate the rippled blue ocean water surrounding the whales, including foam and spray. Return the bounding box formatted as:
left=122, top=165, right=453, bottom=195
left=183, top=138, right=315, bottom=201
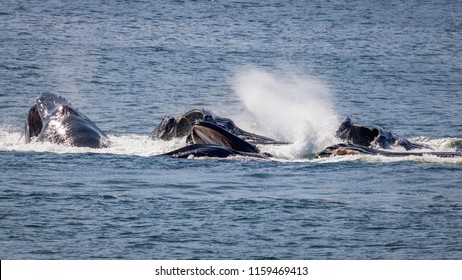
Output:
left=0, top=0, right=462, bottom=259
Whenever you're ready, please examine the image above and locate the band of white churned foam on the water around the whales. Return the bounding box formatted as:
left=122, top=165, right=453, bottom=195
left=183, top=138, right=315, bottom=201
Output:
left=0, top=129, right=462, bottom=165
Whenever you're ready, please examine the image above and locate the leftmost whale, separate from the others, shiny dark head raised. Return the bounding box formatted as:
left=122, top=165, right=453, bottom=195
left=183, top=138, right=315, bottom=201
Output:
left=24, top=93, right=110, bottom=148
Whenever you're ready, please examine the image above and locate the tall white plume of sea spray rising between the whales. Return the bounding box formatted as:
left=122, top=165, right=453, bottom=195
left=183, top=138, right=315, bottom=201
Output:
left=234, top=69, right=339, bottom=157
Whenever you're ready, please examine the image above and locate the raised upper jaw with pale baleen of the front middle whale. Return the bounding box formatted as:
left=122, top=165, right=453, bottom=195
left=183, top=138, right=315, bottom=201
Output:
left=189, top=122, right=259, bottom=153
